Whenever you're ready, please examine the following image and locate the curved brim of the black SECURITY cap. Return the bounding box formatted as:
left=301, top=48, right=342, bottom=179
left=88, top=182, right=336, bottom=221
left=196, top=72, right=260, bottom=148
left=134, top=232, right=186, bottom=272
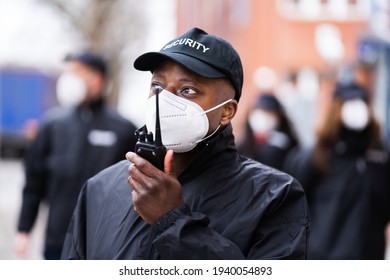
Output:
left=134, top=52, right=226, bottom=78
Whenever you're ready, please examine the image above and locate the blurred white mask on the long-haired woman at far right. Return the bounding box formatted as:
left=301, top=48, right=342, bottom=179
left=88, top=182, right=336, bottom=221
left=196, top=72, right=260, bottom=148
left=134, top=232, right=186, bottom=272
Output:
left=341, top=99, right=369, bottom=131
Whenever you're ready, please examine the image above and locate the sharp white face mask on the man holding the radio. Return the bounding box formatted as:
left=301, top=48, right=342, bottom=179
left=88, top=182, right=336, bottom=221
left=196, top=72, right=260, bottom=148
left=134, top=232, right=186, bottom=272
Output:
left=146, top=90, right=232, bottom=153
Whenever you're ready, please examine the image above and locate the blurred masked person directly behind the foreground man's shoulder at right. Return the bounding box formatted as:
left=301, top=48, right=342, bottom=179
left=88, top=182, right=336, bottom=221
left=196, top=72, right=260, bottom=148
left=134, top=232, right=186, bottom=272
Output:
left=237, top=92, right=298, bottom=170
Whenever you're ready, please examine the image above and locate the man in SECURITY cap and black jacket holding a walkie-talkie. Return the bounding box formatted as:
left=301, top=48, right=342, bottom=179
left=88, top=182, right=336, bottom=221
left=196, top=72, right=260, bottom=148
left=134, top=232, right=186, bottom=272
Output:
left=62, top=28, right=309, bottom=259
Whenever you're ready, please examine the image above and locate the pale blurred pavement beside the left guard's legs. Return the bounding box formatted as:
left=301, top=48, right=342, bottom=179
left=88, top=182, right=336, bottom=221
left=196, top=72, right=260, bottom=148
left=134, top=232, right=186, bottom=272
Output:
left=0, top=159, right=47, bottom=260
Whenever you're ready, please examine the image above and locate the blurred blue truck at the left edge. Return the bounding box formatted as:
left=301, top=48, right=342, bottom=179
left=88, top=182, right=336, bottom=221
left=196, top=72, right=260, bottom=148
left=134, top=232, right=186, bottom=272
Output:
left=0, top=69, right=56, bottom=158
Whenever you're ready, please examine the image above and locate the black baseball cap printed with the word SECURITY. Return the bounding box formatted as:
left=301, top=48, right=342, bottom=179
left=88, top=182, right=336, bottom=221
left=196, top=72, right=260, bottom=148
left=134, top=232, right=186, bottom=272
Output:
left=134, top=28, right=244, bottom=101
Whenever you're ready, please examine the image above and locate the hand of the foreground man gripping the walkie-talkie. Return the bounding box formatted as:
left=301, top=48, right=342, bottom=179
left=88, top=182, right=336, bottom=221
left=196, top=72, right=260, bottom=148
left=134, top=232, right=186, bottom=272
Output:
left=126, top=150, right=184, bottom=224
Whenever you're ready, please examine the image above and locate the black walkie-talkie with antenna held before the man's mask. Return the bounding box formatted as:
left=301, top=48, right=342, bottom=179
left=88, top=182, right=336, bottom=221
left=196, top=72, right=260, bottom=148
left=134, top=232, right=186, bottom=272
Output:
left=135, top=89, right=167, bottom=171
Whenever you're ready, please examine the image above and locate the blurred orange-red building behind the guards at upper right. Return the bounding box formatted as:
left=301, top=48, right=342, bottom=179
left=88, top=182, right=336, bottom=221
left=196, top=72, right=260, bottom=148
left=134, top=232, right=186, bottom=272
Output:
left=177, top=0, right=369, bottom=143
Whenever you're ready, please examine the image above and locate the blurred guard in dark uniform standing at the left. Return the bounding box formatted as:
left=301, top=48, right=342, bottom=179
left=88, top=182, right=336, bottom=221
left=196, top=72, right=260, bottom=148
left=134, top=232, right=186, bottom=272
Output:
left=15, top=51, right=136, bottom=259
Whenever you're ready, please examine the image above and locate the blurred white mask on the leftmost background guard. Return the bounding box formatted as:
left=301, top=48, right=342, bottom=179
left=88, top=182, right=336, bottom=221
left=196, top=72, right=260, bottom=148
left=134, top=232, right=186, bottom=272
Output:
left=56, top=72, right=87, bottom=107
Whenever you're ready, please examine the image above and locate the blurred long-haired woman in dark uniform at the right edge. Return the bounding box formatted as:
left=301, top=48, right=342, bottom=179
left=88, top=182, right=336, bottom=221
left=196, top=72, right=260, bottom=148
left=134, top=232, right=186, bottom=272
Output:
left=286, top=82, right=390, bottom=260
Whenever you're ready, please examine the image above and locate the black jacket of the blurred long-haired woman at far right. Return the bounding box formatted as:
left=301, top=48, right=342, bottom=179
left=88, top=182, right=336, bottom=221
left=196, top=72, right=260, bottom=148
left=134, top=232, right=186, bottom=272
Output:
left=285, top=137, right=390, bottom=260
